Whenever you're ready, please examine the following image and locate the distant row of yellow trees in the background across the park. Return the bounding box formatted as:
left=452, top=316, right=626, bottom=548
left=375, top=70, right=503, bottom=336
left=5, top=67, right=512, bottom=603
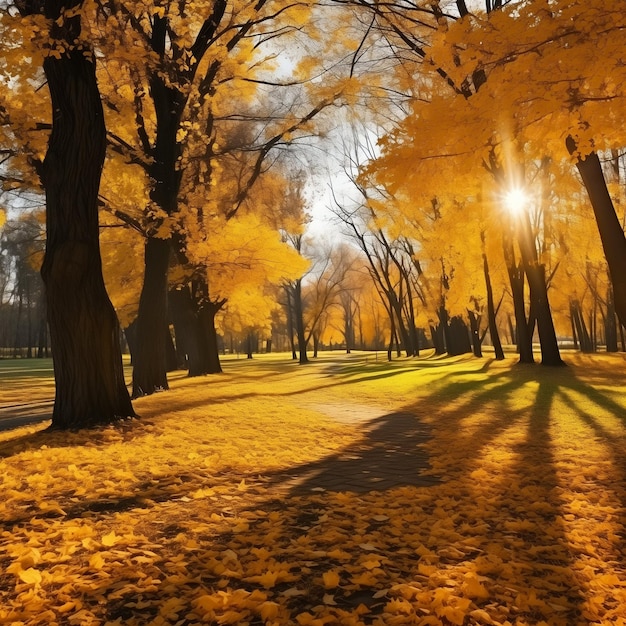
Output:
left=0, top=191, right=623, bottom=370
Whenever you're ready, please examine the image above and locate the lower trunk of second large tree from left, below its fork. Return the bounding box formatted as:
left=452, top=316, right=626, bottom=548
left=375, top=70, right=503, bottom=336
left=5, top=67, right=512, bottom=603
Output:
left=133, top=237, right=170, bottom=398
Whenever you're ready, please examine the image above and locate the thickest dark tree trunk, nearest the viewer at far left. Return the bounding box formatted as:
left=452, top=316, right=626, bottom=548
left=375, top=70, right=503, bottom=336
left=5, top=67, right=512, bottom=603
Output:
left=41, top=6, right=135, bottom=429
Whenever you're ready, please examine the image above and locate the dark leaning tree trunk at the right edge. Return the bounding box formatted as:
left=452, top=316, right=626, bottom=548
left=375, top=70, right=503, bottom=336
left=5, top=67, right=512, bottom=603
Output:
left=565, top=137, right=626, bottom=326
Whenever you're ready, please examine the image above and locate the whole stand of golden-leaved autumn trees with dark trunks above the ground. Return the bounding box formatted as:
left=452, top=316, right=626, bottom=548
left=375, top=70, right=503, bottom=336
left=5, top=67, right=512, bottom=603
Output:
left=0, top=0, right=626, bottom=428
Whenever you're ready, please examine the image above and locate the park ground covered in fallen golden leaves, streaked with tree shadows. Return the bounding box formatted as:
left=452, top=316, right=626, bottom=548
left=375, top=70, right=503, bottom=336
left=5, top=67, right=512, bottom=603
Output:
left=0, top=353, right=626, bottom=626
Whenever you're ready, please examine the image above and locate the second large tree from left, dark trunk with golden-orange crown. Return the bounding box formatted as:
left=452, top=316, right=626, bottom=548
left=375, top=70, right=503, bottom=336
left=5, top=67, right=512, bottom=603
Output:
left=87, top=0, right=348, bottom=395
